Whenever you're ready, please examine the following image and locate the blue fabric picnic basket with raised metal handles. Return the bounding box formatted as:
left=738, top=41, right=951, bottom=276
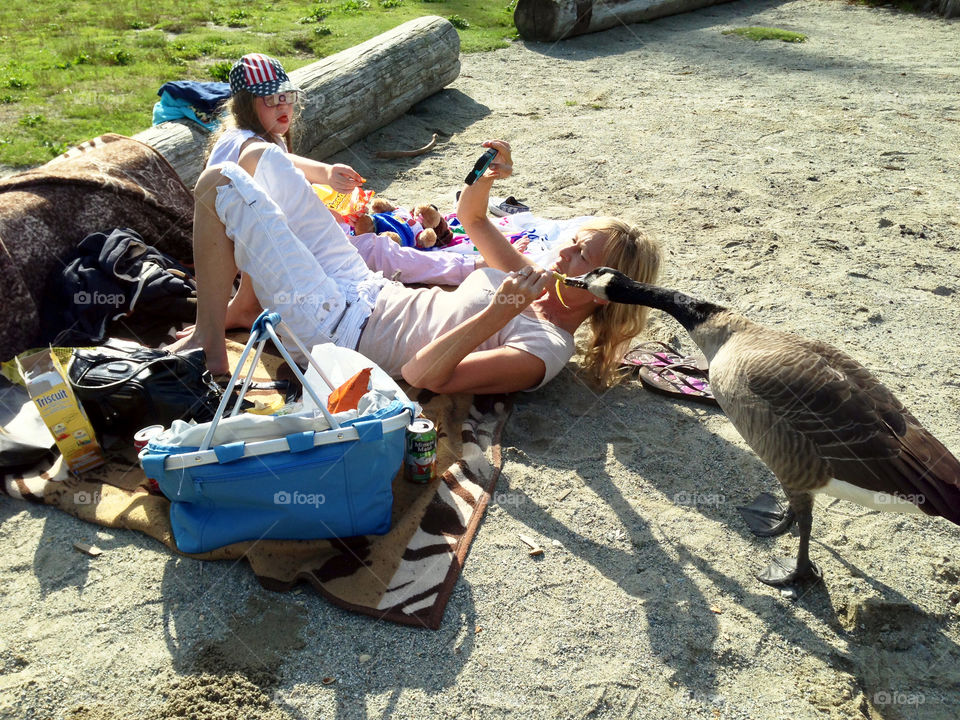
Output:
left=140, top=311, right=416, bottom=553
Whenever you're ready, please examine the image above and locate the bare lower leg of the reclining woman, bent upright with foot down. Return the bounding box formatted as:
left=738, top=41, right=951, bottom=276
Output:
left=167, top=168, right=236, bottom=375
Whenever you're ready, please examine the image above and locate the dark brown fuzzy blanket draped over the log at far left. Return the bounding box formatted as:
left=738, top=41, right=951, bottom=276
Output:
left=0, top=135, right=193, bottom=360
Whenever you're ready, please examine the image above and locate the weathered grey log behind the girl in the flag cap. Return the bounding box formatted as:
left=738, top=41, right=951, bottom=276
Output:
left=134, top=16, right=460, bottom=187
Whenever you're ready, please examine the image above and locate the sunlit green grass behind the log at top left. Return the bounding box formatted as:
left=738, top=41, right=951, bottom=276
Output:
left=0, top=0, right=517, bottom=168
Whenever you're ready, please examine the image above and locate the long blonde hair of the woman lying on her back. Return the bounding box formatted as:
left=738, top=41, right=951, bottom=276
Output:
left=580, top=217, right=661, bottom=387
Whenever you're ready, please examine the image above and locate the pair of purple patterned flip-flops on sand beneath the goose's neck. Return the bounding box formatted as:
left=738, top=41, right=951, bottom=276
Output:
left=621, top=342, right=718, bottom=406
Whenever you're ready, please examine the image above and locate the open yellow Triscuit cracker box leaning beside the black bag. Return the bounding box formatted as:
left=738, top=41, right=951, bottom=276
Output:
left=17, top=350, right=104, bottom=473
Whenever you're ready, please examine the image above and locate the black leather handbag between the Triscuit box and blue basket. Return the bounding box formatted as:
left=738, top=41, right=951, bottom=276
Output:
left=68, top=340, right=223, bottom=435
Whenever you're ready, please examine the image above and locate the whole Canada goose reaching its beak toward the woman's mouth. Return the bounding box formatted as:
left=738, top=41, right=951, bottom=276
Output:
left=564, top=267, right=960, bottom=586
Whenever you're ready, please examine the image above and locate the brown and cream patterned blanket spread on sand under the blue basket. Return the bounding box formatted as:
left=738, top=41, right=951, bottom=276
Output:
left=2, top=342, right=511, bottom=630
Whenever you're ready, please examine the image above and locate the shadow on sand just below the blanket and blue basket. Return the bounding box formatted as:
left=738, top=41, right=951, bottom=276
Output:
left=161, top=558, right=476, bottom=718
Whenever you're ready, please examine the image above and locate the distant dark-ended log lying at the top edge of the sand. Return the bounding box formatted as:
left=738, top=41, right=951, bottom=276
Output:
left=513, top=0, right=730, bottom=42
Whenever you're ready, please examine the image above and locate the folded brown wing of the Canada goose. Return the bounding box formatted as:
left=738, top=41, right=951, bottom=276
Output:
left=747, top=337, right=960, bottom=524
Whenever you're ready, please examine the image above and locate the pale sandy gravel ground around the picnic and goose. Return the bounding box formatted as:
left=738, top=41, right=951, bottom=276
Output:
left=0, top=0, right=960, bottom=720
